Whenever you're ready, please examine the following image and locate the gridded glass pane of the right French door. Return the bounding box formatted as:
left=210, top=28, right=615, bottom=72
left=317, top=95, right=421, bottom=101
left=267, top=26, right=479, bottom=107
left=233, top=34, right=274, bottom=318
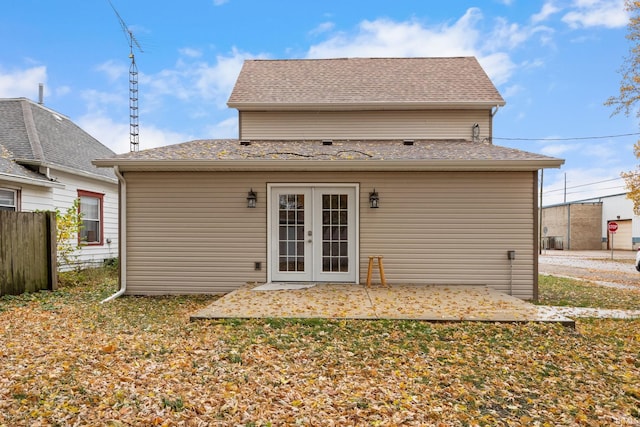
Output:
left=322, top=194, right=349, bottom=272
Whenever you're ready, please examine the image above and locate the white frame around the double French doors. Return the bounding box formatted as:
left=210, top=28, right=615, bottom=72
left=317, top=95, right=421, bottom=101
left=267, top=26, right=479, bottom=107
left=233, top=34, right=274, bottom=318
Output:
left=267, top=182, right=360, bottom=284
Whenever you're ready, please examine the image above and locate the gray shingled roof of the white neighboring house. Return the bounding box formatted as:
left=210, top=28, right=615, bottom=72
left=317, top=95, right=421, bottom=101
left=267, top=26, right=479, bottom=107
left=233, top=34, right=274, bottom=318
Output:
left=0, top=98, right=116, bottom=181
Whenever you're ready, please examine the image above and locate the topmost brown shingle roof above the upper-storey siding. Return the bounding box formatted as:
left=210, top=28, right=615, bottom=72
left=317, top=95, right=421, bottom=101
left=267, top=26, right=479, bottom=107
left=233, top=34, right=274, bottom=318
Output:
left=228, top=57, right=504, bottom=110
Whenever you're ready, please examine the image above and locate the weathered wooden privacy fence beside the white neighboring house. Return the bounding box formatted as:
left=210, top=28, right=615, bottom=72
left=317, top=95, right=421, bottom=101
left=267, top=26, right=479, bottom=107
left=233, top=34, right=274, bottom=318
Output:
left=0, top=210, right=58, bottom=295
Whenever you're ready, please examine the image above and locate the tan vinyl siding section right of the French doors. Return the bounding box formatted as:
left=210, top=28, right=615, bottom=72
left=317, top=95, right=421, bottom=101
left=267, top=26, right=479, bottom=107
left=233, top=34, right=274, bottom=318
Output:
left=360, top=172, right=535, bottom=298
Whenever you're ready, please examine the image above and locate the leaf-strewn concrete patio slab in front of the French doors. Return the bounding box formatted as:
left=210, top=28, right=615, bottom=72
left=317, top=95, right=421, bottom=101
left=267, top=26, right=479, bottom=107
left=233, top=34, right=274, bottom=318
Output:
left=191, top=284, right=575, bottom=326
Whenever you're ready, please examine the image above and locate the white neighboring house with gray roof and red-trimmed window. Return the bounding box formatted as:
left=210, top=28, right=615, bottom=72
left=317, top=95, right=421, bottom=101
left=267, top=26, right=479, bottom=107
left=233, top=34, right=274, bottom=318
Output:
left=0, top=98, right=118, bottom=268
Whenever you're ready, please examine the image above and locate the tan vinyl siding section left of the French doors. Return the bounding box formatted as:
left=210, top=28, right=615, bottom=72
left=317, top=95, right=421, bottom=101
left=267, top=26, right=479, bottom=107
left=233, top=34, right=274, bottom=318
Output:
left=125, top=173, right=266, bottom=294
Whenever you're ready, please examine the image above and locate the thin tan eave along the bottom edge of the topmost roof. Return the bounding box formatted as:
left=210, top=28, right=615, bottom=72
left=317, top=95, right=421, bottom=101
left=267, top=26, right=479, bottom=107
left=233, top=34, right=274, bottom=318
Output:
left=227, top=99, right=506, bottom=111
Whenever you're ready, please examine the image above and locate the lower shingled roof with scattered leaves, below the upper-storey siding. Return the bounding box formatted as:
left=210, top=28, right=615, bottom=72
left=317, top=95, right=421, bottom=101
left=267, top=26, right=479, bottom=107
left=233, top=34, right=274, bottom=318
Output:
left=95, top=139, right=563, bottom=170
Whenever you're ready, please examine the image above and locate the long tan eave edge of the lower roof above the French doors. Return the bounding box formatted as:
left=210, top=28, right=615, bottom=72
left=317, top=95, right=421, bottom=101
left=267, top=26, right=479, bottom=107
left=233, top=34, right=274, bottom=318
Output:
left=93, top=158, right=564, bottom=172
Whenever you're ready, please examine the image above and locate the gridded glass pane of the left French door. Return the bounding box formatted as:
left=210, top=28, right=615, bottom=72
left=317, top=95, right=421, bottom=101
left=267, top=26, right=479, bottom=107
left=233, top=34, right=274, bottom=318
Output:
left=278, top=194, right=305, bottom=271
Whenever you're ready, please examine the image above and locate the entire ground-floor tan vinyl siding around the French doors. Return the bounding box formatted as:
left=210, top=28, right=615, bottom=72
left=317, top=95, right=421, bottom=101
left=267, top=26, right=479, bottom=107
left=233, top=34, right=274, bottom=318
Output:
left=125, top=172, right=535, bottom=298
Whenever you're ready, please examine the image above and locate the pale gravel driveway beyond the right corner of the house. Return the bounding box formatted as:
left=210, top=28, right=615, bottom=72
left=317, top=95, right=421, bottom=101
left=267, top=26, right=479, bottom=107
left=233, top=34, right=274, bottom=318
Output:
left=539, top=251, right=640, bottom=289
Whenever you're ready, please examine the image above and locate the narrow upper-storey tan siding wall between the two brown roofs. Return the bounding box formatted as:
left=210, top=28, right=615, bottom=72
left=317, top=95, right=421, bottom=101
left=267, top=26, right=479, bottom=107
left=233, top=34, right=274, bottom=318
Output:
left=240, top=110, right=491, bottom=140
